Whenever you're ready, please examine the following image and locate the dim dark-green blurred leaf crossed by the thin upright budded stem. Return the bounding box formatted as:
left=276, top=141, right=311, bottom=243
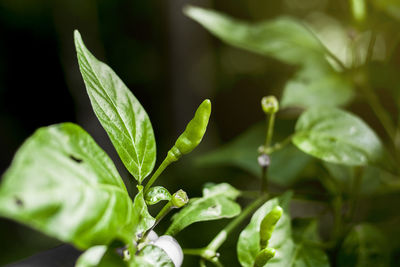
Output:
left=197, top=124, right=312, bottom=186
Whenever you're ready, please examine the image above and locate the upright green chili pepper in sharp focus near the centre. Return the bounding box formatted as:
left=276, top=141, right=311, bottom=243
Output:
left=168, top=99, right=211, bottom=160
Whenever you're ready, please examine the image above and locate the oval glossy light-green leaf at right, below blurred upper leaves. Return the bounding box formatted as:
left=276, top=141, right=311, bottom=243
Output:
left=292, top=107, right=385, bottom=166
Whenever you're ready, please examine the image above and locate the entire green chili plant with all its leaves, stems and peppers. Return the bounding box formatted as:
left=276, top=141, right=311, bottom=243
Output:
left=0, top=0, right=400, bottom=267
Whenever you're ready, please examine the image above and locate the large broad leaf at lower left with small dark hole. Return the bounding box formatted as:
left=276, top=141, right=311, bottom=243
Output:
left=0, top=123, right=154, bottom=249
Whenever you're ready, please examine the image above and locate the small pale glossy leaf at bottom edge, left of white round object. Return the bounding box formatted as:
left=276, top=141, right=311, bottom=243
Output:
left=129, top=245, right=175, bottom=267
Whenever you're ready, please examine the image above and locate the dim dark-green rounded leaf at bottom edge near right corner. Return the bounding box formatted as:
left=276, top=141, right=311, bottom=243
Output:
left=338, top=224, right=390, bottom=267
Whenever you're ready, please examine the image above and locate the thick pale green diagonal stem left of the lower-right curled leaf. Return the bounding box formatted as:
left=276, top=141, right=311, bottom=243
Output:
left=206, top=194, right=268, bottom=252
